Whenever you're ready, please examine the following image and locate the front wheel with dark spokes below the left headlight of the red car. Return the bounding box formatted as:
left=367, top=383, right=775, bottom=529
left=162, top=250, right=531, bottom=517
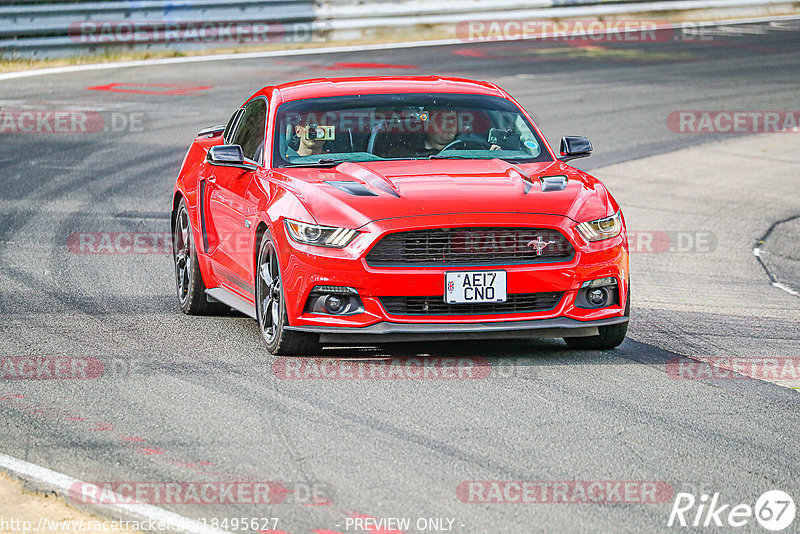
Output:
left=255, top=231, right=319, bottom=356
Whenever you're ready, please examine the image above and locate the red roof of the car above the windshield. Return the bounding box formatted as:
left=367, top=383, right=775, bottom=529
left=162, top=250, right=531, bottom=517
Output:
left=253, top=76, right=508, bottom=101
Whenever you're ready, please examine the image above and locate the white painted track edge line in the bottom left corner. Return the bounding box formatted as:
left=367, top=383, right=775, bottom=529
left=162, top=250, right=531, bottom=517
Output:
left=0, top=453, right=227, bottom=534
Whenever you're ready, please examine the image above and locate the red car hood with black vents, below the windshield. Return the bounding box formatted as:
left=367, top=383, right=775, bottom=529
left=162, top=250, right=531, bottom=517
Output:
left=272, top=159, right=618, bottom=228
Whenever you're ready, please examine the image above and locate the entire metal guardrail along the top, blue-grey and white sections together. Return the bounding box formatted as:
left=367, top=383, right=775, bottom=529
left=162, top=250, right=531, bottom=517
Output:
left=0, top=0, right=797, bottom=59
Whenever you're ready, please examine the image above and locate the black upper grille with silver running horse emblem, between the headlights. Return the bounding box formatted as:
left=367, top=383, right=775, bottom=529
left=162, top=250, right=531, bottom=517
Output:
left=367, top=228, right=574, bottom=267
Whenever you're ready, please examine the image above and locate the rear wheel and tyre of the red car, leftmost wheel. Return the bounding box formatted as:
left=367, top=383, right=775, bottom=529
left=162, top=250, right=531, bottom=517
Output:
left=172, top=199, right=228, bottom=315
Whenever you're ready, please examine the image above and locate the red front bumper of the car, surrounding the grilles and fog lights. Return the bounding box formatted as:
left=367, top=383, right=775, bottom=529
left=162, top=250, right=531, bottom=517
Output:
left=274, top=214, right=628, bottom=341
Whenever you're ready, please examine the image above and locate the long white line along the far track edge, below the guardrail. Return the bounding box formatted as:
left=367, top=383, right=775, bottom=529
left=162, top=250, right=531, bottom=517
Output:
left=0, top=15, right=800, bottom=80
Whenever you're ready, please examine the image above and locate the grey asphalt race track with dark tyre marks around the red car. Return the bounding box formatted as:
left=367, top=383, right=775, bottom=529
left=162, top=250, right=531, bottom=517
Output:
left=0, top=18, right=800, bottom=534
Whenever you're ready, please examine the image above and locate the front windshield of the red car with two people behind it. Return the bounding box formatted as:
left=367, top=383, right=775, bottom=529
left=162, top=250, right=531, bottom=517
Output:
left=273, top=93, right=552, bottom=167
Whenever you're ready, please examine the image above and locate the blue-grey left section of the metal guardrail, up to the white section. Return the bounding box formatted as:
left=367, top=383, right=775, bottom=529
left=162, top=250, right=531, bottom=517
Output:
left=0, top=0, right=315, bottom=59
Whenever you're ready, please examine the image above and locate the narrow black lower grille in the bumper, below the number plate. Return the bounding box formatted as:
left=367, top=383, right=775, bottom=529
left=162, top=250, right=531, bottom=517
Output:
left=380, top=292, right=564, bottom=315
